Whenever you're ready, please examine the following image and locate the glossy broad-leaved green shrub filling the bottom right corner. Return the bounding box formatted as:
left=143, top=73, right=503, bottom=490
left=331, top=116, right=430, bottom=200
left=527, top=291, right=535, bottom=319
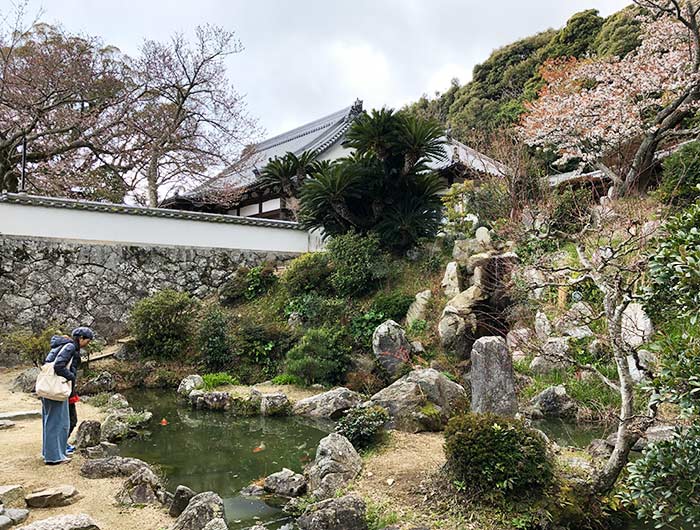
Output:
left=623, top=425, right=700, bottom=528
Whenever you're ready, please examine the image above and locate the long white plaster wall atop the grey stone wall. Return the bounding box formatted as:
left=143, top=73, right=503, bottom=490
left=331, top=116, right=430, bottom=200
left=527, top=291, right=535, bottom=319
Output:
left=0, top=203, right=318, bottom=252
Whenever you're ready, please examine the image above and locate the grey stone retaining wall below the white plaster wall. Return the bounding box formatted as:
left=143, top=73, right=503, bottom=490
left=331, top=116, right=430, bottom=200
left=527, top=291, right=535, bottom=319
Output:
left=0, top=235, right=297, bottom=339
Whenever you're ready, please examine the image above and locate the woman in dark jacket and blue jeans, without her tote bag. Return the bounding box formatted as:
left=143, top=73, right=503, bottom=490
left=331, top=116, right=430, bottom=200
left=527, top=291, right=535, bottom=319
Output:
left=41, top=327, right=95, bottom=465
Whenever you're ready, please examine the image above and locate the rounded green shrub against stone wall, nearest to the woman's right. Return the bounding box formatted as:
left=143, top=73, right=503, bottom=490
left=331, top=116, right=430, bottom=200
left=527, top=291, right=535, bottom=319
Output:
left=129, top=289, right=199, bottom=359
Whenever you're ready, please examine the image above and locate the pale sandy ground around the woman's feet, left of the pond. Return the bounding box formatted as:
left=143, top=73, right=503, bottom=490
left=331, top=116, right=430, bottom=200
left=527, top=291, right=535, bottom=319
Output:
left=0, top=369, right=173, bottom=530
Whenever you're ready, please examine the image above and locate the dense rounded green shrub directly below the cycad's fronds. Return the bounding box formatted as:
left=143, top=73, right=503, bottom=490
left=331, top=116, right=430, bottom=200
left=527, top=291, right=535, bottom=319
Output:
left=328, top=232, right=389, bottom=297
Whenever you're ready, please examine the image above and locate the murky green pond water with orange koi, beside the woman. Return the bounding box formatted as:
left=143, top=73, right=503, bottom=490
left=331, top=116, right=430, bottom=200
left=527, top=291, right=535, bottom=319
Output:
left=120, top=391, right=328, bottom=530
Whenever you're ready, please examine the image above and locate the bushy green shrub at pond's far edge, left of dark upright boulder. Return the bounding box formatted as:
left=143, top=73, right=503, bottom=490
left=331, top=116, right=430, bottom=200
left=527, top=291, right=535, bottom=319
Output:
left=286, top=327, right=350, bottom=385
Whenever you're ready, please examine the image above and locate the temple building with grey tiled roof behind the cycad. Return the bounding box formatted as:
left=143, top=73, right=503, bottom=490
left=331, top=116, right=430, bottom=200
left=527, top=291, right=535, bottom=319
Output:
left=163, top=99, right=505, bottom=220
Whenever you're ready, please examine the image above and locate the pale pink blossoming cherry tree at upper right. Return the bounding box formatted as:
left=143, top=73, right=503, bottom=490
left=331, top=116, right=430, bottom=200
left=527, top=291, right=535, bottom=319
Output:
left=520, top=0, right=700, bottom=194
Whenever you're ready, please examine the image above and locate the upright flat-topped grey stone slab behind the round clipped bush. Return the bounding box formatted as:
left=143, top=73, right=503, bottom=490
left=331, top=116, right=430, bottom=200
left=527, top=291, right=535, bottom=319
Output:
left=471, top=337, right=518, bottom=416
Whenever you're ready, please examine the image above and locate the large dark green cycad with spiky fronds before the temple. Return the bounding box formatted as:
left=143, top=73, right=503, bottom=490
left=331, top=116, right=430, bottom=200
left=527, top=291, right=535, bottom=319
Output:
left=300, top=109, right=444, bottom=250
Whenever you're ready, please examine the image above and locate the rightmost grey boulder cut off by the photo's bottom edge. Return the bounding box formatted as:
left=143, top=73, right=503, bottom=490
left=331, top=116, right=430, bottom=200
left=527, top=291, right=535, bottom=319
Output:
left=297, top=495, right=367, bottom=530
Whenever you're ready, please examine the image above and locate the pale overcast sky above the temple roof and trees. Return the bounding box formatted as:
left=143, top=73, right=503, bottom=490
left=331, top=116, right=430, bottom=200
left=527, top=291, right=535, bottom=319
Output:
left=0, top=0, right=630, bottom=136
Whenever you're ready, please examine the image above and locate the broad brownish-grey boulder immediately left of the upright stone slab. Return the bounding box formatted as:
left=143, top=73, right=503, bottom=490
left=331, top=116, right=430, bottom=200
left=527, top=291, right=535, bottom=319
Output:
left=371, top=368, right=468, bottom=432
